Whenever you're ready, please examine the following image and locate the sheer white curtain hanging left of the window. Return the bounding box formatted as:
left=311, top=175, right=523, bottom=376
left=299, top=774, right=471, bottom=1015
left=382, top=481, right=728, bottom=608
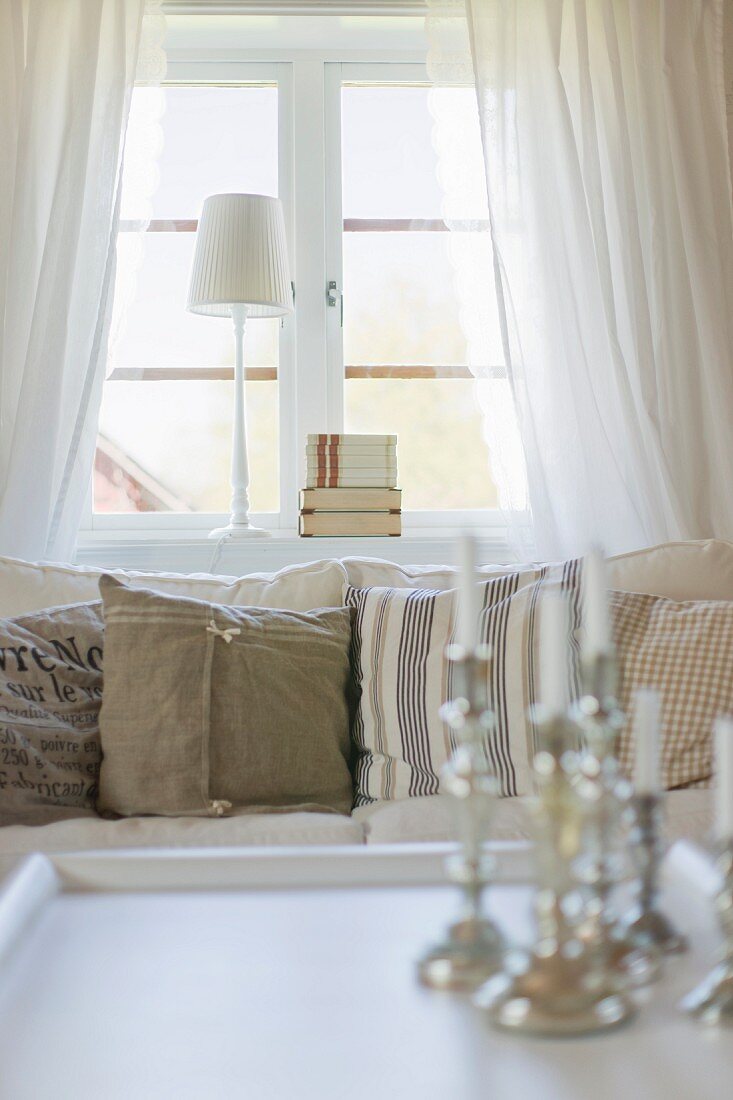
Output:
left=0, top=0, right=160, bottom=560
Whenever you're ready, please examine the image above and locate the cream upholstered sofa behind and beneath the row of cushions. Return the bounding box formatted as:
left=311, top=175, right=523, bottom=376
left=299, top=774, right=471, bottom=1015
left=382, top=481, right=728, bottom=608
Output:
left=0, top=540, right=733, bottom=877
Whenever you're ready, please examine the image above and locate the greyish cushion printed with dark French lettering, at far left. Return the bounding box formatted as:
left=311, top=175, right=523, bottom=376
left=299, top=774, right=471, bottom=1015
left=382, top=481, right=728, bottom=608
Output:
left=0, top=601, right=103, bottom=825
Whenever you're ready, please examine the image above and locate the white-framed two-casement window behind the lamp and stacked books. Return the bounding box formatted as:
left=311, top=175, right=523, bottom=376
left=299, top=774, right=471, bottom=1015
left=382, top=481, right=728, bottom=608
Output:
left=91, top=52, right=496, bottom=530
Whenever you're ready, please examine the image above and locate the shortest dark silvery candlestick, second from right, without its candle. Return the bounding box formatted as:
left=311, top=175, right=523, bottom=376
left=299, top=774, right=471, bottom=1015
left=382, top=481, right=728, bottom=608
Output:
left=624, top=794, right=688, bottom=955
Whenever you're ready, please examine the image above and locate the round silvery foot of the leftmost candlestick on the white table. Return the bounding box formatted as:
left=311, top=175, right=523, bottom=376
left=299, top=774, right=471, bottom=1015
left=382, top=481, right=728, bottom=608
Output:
left=417, top=917, right=504, bottom=992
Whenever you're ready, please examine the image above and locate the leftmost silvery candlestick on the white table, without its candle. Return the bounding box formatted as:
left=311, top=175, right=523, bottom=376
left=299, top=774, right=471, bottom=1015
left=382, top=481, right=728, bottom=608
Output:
left=418, top=646, right=504, bottom=991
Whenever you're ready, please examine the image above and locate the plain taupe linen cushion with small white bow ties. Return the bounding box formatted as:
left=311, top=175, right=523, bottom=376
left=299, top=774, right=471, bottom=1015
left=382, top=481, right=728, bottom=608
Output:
left=98, top=576, right=352, bottom=816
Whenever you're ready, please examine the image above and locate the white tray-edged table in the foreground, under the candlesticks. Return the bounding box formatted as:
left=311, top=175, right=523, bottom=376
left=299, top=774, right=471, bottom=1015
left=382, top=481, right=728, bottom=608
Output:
left=0, top=846, right=733, bottom=1100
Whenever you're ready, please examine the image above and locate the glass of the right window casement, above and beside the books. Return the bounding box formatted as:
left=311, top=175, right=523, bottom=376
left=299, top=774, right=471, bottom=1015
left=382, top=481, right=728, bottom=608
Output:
left=341, top=85, right=496, bottom=512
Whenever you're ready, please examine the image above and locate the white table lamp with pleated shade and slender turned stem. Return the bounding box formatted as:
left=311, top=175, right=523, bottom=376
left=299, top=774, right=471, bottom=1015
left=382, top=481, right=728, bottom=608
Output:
left=186, top=195, right=293, bottom=539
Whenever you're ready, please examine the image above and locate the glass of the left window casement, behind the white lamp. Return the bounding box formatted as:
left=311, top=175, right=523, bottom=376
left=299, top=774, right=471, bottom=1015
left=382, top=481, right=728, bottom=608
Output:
left=95, top=85, right=280, bottom=513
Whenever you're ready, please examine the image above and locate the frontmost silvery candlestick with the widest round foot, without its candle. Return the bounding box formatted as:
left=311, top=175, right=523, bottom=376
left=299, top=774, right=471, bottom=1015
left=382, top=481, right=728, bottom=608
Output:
left=475, top=715, right=635, bottom=1035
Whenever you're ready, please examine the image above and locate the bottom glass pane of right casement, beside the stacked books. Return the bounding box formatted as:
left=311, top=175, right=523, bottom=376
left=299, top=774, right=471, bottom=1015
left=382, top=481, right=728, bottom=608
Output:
left=346, top=378, right=497, bottom=512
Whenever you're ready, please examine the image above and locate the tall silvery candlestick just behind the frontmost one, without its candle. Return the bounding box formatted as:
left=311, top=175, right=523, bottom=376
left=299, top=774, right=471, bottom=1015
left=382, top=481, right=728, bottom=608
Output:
left=573, top=650, right=661, bottom=986
